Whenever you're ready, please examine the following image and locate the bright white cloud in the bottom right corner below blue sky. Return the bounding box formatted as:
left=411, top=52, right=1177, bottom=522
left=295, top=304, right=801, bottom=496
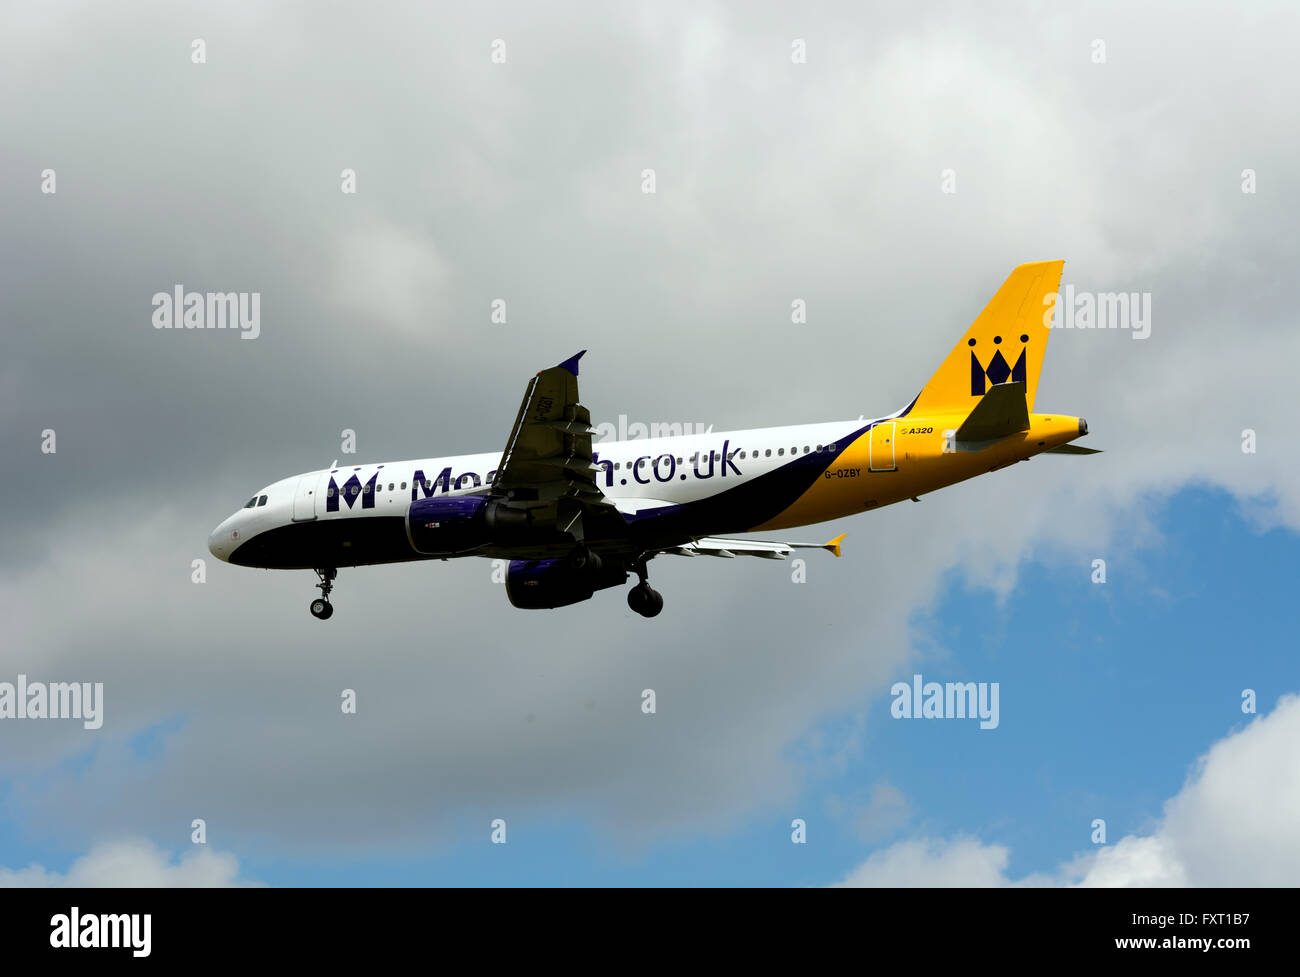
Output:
left=841, top=695, right=1300, bottom=887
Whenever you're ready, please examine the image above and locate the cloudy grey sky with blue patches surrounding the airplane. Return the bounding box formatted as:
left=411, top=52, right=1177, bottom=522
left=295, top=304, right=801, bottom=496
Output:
left=0, top=3, right=1300, bottom=886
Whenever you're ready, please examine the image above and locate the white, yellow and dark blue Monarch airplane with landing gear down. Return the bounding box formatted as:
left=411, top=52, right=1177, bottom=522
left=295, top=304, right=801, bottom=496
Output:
left=208, top=261, right=1097, bottom=620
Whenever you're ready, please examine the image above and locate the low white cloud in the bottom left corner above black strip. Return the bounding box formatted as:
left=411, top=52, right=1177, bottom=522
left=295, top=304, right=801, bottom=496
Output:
left=0, top=838, right=255, bottom=889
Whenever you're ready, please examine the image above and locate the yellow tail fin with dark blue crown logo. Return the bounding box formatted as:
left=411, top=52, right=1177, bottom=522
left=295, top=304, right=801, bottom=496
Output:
left=911, top=261, right=1065, bottom=417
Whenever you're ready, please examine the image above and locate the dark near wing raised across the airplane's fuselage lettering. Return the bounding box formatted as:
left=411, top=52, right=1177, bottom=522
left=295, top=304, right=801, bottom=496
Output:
left=491, top=349, right=612, bottom=531
